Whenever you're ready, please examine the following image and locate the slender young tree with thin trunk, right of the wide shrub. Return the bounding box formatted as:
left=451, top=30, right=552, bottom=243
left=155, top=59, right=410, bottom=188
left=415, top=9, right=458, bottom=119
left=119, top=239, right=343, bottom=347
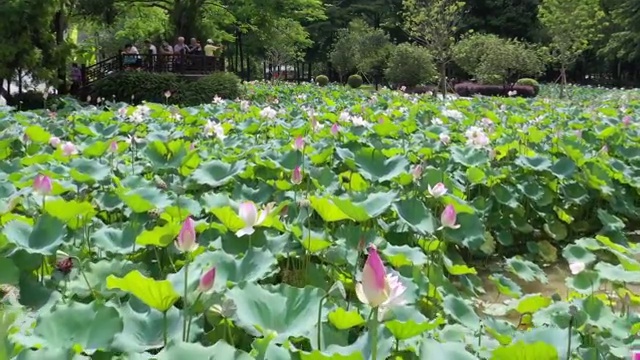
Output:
left=538, top=0, right=605, bottom=97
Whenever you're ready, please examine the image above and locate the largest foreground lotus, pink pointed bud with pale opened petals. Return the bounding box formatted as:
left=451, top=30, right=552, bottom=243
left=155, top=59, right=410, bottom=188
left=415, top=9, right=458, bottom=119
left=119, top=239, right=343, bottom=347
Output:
left=356, top=244, right=407, bottom=319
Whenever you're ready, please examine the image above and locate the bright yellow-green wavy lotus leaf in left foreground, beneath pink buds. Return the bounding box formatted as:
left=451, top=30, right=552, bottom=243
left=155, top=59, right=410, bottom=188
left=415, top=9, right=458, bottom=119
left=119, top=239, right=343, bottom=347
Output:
left=106, top=270, right=180, bottom=311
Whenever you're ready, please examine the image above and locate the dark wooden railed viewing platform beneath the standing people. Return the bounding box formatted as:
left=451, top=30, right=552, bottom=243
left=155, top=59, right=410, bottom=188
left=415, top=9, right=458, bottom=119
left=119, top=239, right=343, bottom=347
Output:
left=81, top=54, right=225, bottom=87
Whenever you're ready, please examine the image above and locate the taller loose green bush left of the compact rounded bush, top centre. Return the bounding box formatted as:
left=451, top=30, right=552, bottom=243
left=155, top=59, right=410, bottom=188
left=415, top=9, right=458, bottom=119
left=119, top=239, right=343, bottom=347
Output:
left=329, top=20, right=393, bottom=81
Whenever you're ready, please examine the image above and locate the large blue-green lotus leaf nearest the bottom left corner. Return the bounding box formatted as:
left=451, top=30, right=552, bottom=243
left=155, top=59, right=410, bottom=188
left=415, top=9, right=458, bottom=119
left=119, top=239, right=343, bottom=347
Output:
left=33, top=302, right=123, bottom=352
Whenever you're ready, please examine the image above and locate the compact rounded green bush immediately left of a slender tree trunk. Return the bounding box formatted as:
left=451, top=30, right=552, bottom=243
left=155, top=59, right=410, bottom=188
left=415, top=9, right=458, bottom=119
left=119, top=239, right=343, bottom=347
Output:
left=385, top=44, right=437, bottom=87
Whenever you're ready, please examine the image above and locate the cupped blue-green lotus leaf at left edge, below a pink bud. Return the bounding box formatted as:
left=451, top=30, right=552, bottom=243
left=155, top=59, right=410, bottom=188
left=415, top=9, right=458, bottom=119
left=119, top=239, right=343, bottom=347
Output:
left=2, top=214, right=66, bottom=255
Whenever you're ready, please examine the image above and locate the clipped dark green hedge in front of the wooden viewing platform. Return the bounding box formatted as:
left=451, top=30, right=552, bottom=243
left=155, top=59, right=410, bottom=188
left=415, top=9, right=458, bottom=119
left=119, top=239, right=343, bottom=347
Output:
left=91, top=71, right=240, bottom=106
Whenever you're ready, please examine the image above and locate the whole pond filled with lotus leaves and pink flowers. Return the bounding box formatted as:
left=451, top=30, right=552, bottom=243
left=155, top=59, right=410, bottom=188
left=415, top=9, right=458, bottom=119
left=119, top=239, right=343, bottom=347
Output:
left=0, top=84, right=640, bottom=360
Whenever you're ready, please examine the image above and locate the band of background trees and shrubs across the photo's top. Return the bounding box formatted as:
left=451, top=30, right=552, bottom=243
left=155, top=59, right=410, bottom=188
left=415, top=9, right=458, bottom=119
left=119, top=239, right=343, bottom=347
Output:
left=0, top=0, right=640, bottom=97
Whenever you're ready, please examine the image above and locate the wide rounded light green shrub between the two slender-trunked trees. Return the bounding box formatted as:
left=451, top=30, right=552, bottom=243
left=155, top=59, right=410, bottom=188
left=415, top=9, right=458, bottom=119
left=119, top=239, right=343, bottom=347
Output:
left=453, top=34, right=545, bottom=84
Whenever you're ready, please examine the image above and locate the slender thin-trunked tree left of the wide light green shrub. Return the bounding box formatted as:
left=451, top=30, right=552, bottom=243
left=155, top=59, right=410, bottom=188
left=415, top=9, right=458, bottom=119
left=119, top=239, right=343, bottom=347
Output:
left=403, top=0, right=464, bottom=98
